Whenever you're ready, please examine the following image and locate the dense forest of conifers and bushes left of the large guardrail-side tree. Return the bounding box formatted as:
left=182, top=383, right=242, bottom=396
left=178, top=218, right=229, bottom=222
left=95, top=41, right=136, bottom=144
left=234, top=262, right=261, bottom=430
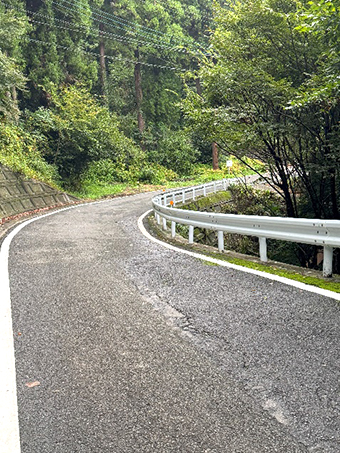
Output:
left=0, top=0, right=222, bottom=192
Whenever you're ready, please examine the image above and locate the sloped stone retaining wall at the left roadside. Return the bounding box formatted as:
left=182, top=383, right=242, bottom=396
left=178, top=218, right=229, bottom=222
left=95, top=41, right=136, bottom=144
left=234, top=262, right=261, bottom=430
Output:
left=0, top=164, right=76, bottom=219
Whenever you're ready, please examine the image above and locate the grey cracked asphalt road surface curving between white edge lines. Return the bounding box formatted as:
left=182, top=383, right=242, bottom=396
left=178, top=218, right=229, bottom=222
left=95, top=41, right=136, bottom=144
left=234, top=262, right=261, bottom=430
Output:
left=8, top=194, right=340, bottom=453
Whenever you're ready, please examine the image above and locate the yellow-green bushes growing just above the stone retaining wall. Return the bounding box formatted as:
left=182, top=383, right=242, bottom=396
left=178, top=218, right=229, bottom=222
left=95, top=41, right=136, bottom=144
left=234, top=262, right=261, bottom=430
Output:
left=0, top=123, right=59, bottom=185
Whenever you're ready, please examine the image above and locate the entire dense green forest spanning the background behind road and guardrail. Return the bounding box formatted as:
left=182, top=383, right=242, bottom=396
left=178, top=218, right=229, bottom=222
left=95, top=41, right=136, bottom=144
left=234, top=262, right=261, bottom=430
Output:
left=0, top=0, right=340, bottom=219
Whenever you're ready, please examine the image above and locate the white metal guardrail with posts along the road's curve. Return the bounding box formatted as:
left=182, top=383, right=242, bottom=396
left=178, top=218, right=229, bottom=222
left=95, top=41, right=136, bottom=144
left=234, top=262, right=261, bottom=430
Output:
left=152, top=179, right=340, bottom=277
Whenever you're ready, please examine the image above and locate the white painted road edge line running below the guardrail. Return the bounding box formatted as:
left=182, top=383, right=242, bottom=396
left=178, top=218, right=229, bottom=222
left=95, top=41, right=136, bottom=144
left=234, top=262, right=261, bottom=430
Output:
left=138, top=209, right=340, bottom=300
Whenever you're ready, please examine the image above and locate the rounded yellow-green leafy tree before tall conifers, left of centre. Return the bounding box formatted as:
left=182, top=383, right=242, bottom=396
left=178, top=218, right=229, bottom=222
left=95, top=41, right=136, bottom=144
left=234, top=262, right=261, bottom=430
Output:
left=29, top=85, right=143, bottom=179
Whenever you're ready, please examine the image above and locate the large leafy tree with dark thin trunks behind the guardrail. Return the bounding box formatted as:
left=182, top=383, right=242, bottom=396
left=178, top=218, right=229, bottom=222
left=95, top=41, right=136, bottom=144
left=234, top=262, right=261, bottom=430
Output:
left=183, top=0, right=340, bottom=218
